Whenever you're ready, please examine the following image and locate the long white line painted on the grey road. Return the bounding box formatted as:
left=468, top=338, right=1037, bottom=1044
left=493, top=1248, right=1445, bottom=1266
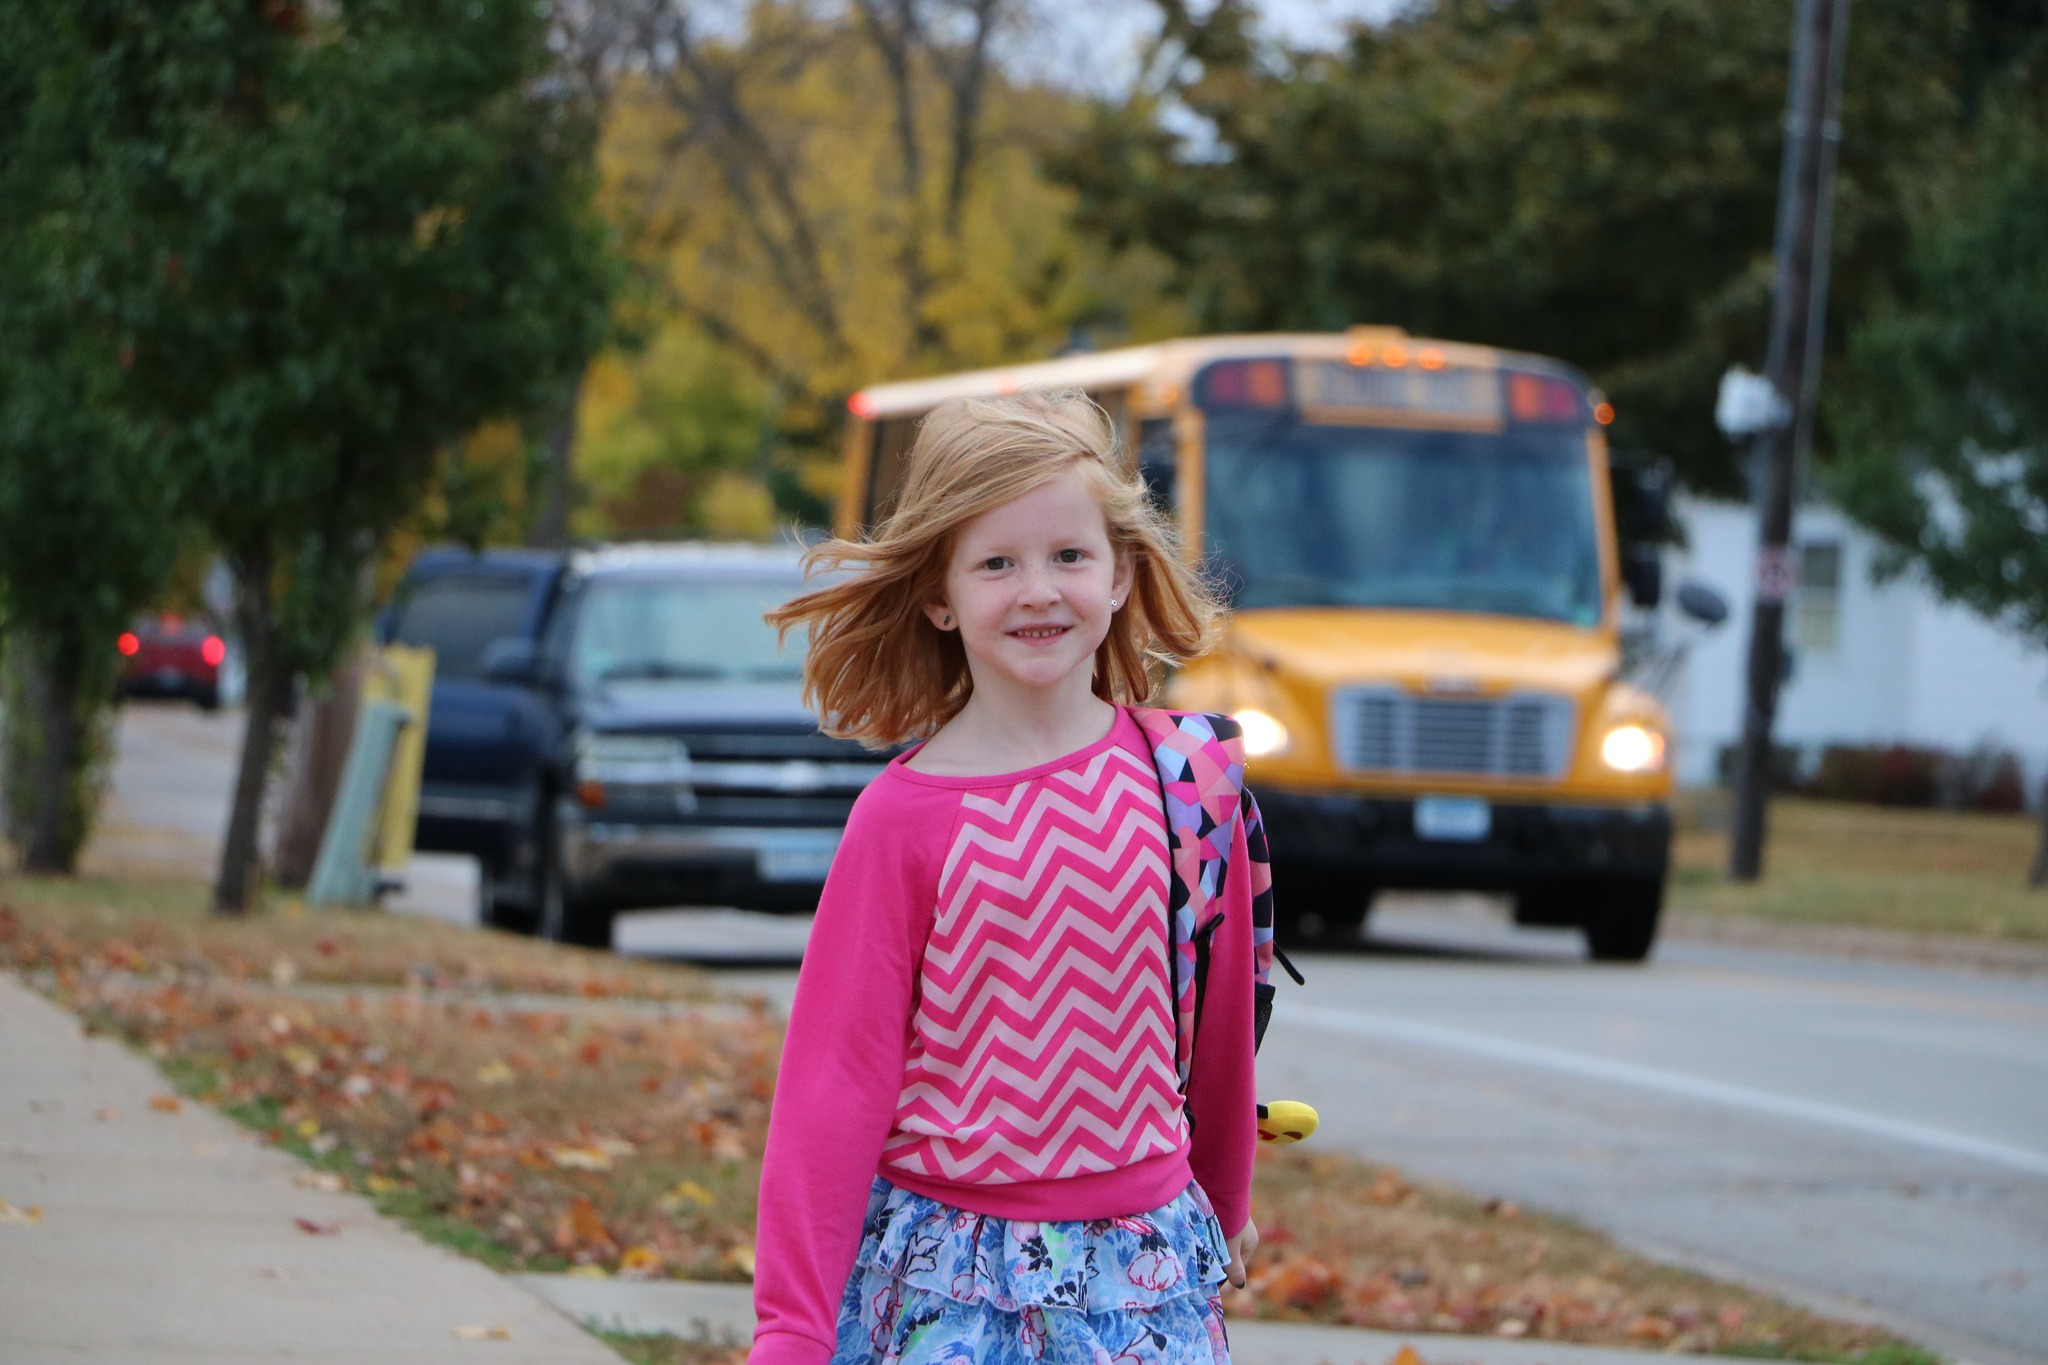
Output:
left=1274, top=1001, right=2048, bottom=1175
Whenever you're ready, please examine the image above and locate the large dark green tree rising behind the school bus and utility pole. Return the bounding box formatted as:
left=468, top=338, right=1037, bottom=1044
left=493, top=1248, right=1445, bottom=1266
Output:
left=1063, top=0, right=1960, bottom=491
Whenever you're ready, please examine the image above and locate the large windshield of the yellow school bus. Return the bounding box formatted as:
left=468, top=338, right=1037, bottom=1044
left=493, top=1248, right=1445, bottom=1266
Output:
left=1204, top=413, right=1599, bottom=626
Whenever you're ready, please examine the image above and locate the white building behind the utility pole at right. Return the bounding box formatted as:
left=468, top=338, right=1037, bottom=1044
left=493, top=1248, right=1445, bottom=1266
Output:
left=1663, top=497, right=2048, bottom=800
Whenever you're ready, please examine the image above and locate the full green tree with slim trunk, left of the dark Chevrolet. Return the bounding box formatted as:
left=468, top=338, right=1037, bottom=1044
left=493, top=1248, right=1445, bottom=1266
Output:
left=74, top=0, right=610, bottom=913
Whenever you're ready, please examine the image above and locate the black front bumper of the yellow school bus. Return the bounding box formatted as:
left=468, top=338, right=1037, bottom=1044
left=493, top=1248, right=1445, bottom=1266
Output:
left=1257, top=788, right=1671, bottom=892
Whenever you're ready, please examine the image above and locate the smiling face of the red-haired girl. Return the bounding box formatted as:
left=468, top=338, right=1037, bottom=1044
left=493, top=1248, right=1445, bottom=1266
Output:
left=926, top=469, right=1133, bottom=694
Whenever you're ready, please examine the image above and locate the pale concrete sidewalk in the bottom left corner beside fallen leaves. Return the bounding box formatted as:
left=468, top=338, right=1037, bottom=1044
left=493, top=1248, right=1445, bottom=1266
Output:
left=0, top=972, right=618, bottom=1365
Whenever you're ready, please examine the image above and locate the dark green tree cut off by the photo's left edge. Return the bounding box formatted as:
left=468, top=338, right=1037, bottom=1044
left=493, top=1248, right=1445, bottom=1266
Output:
left=0, top=0, right=180, bottom=872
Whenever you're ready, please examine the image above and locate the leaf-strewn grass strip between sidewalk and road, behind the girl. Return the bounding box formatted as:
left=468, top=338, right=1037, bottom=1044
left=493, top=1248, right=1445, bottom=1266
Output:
left=0, top=882, right=1935, bottom=1365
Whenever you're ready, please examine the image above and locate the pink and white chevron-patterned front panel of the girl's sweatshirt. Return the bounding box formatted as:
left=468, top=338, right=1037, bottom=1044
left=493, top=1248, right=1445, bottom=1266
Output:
left=883, top=745, right=1188, bottom=1185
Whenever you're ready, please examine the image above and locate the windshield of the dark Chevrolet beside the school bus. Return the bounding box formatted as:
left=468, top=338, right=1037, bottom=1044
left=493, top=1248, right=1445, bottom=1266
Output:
left=569, top=577, right=803, bottom=688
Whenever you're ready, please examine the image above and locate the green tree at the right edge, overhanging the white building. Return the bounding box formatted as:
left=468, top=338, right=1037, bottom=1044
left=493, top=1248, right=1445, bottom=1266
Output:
left=1831, top=82, right=2048, bottom=886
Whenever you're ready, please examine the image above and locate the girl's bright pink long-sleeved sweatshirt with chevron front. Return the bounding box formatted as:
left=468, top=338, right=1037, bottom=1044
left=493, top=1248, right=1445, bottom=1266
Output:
left=748, top=712, right=1257, bottom=1365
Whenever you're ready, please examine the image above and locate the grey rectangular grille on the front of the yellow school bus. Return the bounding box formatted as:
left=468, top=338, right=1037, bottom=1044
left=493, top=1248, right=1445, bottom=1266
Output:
left=1329, top=688, right=1575, bottom=778
